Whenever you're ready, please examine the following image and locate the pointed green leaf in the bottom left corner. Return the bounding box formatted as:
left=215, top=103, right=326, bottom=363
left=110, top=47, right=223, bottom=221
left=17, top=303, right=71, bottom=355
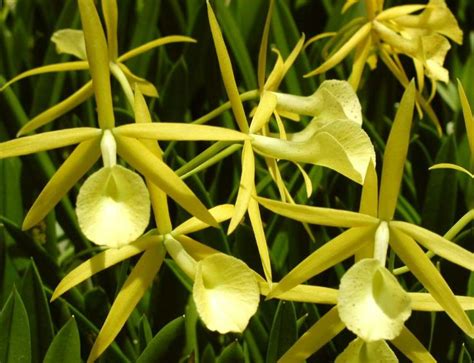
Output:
left=0, top=288, right=31, bottom=363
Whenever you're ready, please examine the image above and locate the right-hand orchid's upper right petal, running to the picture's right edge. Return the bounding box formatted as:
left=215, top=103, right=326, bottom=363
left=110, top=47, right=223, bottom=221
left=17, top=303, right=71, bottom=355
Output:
left=390, top=221, right=474, bottom=271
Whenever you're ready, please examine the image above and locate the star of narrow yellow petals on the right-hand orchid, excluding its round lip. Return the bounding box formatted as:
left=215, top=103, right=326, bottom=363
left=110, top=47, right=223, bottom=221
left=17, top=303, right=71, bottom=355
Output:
left=257, top=82, right=474, bottom=336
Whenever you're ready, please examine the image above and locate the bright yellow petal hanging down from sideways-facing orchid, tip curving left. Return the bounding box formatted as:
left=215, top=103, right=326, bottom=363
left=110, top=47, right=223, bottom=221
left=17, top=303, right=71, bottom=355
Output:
left=227, top=141, right=255, bottom=234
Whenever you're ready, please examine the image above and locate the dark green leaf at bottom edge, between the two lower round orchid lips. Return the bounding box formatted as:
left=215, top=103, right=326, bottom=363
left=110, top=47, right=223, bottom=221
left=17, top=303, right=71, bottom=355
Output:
left=266, top=301, right=298, bottom=363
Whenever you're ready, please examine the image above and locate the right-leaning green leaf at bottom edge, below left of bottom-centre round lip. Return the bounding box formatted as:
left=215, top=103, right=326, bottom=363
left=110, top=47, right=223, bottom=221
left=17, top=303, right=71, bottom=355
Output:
left=137, top=316, right=184, bottom=363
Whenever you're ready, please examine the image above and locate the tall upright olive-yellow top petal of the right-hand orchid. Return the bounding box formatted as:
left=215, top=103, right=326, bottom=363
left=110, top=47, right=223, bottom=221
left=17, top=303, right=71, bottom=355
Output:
left=379, top=81, right=416, bottom=221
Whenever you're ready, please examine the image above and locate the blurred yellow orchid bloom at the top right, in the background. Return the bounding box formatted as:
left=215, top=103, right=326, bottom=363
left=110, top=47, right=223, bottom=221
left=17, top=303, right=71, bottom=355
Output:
left=306, top=0, right=463, bottom=132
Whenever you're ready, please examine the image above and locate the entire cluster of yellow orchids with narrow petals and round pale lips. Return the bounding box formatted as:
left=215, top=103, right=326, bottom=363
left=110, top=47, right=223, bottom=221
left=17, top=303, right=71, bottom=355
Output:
left=0, top=0, right=474, bottom=362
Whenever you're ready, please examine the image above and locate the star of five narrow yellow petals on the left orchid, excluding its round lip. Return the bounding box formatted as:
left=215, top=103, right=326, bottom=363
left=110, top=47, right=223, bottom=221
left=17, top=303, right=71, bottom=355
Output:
left=0, top=0, right=249, bottom=233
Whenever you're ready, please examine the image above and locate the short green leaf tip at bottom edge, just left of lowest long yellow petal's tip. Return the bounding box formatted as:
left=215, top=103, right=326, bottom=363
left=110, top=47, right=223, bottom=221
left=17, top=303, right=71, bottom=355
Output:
left=43, top=316, right=82, bottom=363
